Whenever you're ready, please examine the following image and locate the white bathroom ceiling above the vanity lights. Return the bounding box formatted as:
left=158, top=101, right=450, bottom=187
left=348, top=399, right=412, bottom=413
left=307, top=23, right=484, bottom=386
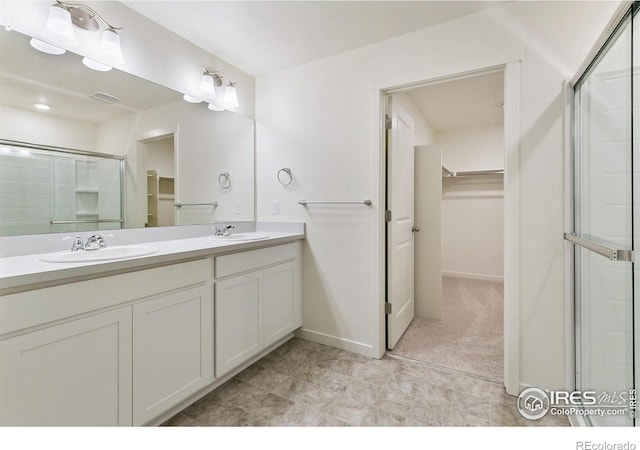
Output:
left=122, top=0, right=502, bottom=76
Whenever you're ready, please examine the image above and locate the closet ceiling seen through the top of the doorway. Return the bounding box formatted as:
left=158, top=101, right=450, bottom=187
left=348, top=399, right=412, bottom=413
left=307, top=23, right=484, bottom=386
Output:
left=406, top=71, right=504, bottom=132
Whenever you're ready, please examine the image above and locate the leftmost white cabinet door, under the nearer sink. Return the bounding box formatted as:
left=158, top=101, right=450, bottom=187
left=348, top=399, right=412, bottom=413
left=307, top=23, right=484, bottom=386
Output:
left=0, top=307, right=131, bottom=426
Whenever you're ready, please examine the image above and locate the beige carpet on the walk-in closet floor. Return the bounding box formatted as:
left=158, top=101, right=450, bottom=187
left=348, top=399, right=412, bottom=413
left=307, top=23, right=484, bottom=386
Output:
left=390, top=277, right=504, bottom=381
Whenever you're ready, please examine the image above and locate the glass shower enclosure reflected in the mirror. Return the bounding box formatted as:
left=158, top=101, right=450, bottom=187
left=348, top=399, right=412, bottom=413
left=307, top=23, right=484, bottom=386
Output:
left=0, top=140, right=124, bottom=236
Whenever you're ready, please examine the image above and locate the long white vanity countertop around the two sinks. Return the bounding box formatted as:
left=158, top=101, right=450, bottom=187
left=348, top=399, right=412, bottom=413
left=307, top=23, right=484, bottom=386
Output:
left=0, top=231, right=304, bottom=295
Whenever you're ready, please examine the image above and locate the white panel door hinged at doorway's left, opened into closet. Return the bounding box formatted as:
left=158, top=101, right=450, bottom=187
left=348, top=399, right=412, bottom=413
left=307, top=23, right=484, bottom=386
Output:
left=387, top=100, right=414, bottom=349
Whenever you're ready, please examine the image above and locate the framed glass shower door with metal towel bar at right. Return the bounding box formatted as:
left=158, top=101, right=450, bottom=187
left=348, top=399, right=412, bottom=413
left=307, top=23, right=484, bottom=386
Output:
left=567, top=7, right=640, bottom=426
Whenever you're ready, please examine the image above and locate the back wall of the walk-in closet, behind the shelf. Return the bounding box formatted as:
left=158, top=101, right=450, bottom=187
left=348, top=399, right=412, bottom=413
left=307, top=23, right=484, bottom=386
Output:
left=436, top=125, right=504, bottom=281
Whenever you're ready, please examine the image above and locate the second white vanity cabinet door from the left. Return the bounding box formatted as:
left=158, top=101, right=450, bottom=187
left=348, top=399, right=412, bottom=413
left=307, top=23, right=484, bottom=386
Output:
left=133, top=285, right=213, bottom=425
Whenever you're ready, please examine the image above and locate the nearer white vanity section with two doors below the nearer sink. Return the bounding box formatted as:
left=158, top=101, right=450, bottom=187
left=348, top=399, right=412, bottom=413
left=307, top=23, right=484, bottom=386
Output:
left=0, top=258, right=213, bottom=426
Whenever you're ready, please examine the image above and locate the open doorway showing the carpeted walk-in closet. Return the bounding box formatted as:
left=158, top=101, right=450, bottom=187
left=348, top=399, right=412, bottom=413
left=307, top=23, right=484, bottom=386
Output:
left=385, top=69, right=505, bottom=382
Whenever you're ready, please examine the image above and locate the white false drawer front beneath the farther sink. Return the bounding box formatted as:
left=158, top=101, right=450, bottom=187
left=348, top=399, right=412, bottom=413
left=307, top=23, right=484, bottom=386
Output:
left=216, top=242, right=298, bottom=278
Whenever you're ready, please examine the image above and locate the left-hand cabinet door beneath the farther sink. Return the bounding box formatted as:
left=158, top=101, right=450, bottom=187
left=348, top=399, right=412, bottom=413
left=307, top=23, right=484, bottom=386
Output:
left=215, top=271, right=263, bottom=377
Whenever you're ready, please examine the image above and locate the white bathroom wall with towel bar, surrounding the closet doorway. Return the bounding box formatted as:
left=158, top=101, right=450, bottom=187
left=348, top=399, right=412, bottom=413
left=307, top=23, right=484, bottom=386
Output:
left=256, top=2, right=617, bottom=388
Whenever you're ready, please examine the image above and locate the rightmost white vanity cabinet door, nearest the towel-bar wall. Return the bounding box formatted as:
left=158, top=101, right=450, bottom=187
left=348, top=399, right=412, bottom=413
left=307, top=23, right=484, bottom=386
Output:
left=263, top=261, right=300, bottom=347
